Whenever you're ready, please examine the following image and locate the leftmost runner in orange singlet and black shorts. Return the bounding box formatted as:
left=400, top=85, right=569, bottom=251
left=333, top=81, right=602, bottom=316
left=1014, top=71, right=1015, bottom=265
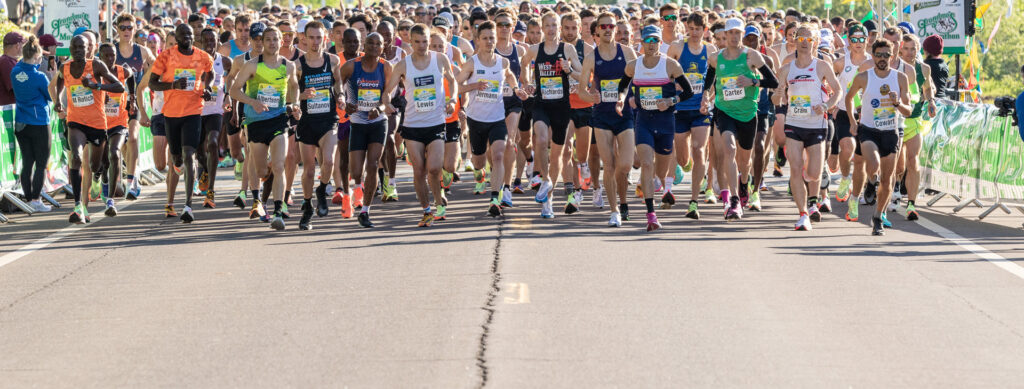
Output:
left=50, top=35, right=125, bottom=224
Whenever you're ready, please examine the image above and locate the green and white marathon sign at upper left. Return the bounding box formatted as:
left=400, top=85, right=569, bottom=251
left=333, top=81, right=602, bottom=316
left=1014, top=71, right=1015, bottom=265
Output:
left=43, top=0, right=99, bottom=55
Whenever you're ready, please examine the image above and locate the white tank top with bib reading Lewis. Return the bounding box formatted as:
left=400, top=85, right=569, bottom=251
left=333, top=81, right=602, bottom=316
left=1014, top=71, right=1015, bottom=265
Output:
left=402, top=51, right=447, bottom=128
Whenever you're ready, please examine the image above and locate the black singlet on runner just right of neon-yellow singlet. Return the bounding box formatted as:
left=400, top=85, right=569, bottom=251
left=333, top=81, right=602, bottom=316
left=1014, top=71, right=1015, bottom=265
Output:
left=299, top=53, right=338, bottom=122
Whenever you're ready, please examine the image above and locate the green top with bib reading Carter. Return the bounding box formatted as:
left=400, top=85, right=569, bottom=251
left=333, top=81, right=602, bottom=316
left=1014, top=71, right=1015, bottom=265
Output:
left=715, top=48, right=758, bottom=122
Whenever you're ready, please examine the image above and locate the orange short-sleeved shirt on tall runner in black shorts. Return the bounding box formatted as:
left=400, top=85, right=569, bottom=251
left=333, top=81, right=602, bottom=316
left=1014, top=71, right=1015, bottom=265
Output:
left=153, top=47, right=213, bottom=118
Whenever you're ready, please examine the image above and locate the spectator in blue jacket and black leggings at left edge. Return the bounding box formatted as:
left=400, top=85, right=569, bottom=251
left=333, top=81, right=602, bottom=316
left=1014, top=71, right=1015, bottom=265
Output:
left=10, top=34, right=50, bottom=212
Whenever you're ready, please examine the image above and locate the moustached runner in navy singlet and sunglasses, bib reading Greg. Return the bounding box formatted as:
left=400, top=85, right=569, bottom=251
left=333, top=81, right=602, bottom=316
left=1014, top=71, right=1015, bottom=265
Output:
left=581, top=12, right=637, bottom=227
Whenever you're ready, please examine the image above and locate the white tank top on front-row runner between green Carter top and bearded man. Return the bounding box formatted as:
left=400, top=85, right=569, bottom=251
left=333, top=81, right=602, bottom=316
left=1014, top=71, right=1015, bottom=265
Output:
left=785, top=58, right=828, bottom=128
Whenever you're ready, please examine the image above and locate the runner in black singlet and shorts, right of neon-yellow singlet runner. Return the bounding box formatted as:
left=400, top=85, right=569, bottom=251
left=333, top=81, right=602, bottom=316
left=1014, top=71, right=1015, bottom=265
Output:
left=296, top=20, right=344, bottom=230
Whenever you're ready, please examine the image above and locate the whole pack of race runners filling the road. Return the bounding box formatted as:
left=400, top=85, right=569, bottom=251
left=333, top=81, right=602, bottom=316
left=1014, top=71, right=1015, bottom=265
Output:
left=26, top=2, right=946, bottom=234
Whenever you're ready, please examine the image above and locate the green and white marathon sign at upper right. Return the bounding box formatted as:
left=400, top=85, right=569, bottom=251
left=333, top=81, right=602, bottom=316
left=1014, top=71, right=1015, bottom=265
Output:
left=910, top=0, right=974, bottom=54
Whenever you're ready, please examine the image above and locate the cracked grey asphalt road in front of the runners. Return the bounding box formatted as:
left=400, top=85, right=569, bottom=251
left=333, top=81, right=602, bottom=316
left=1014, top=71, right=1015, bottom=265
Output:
left=0, top=168, right=1024, bottom=388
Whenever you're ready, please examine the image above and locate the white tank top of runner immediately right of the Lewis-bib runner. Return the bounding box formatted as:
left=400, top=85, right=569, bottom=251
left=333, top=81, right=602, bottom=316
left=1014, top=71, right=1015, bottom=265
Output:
left=466, top=54, right=505, bottom=123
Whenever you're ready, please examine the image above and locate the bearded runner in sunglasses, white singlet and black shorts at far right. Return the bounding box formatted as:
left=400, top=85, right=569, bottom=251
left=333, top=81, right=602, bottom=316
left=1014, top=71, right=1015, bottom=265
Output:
left=846, top=39, right=912, bottom=235
